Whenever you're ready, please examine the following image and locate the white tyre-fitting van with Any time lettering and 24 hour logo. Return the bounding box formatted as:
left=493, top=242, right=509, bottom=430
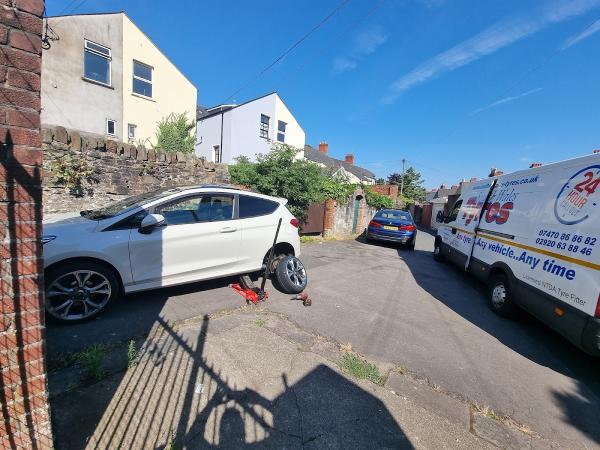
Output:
left=434, top=154, right=600, bottom=356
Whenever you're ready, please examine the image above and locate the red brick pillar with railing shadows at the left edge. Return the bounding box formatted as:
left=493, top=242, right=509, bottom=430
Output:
left=0, top=0, right=52, bottom=449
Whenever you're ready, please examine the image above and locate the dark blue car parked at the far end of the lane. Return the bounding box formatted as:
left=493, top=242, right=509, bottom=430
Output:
left=366, top=209, right=417, bottom=250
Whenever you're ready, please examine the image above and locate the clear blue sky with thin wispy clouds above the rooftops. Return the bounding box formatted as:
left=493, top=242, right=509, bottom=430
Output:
left=46, top=0, right=600, bottom=188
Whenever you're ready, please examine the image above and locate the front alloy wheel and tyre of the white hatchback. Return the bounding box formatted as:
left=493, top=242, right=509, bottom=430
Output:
left=45, top=261, right=121, bottom=323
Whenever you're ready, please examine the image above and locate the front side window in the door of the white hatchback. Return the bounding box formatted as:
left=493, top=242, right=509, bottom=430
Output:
left=156, top=195, right=233, bottom=225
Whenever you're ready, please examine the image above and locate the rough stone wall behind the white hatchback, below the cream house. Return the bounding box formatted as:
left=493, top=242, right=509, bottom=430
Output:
left=42, top=127, right=229, bottom=215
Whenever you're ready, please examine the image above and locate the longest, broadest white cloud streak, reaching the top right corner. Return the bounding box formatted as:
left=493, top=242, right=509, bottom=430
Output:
left=382, top=0, right=600, bottom=104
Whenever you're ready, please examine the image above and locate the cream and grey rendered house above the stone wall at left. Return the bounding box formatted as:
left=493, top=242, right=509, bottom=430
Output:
left=41, top=12, right=197, bottom=144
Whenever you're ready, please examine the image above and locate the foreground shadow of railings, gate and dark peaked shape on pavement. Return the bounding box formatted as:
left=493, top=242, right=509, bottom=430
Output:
left=52, top=316, right=412, bottom=450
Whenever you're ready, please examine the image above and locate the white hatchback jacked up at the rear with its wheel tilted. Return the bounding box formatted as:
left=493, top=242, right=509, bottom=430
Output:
left=43, top=185, right=307, bottom=321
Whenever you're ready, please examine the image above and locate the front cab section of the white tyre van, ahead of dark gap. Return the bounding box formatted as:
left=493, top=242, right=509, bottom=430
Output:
left=438, top=179, right=495, bottom=270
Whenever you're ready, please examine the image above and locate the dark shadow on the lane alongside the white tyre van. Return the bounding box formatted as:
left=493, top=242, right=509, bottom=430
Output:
left=375, top=239, right=600, bottom=443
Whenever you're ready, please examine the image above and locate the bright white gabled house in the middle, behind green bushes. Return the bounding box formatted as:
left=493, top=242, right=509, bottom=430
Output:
left=196, top=92, right=305, bottom=164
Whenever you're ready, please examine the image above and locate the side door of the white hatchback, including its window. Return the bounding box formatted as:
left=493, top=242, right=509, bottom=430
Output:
left=129, top=193, right=241, bottom=286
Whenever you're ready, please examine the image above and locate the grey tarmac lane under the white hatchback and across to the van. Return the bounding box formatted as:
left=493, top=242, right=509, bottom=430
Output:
left=48, top=232, right=600, bottom=448
